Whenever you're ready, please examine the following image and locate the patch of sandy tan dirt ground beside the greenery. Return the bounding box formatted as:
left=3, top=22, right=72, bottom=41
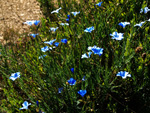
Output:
left=0, top=0, right=43, bottom=41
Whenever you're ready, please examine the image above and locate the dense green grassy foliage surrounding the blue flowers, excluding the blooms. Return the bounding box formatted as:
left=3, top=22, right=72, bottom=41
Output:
left=0, top=0, right=150, bottom=113
